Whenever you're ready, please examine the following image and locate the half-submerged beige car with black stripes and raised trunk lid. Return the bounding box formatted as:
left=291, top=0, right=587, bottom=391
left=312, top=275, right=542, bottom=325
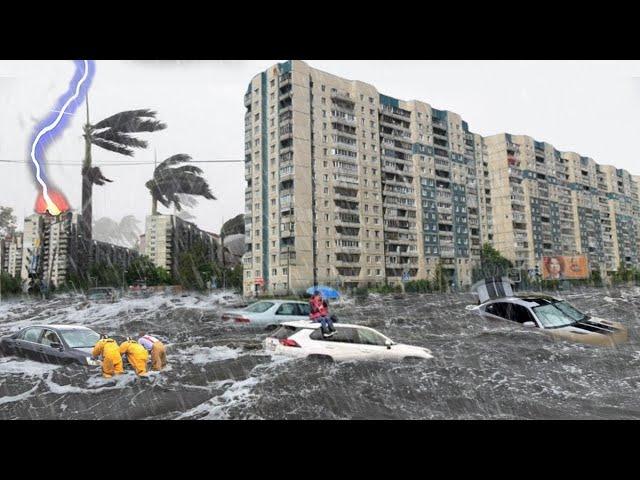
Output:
left=468, top=278, right=628, bottom=346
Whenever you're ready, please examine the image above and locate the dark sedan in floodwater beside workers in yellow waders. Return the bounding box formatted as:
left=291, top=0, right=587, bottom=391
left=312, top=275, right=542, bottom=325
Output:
left=0, top=325, right=100, bottom=366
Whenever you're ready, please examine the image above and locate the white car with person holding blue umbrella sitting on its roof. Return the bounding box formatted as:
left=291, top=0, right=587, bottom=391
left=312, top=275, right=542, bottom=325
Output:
left=265, top=320, right=433, bottom=361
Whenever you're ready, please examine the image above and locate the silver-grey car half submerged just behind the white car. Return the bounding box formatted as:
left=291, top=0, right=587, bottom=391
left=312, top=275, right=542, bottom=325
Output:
left=222, top=300, right=310, bottom=329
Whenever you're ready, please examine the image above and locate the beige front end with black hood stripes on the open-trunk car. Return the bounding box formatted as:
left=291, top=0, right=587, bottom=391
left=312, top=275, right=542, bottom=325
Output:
left=546, top=317, right=629, bottom=347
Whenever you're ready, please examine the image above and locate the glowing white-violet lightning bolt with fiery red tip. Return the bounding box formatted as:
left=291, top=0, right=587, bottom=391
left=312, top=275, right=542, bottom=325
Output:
left=31, top=60, right=93, bottom=215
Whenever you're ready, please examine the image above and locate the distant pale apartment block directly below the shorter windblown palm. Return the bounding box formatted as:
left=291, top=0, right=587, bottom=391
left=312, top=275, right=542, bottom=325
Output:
left=145, top=215, right=218, bottom=275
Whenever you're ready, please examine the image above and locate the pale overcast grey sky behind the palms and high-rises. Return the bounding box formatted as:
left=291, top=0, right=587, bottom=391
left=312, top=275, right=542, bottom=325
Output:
left=0, top=60, right=640, bottom=232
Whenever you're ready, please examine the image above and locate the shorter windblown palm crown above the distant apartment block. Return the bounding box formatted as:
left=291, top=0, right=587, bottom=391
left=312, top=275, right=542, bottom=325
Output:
left=145, top=153, right=216, bottom=215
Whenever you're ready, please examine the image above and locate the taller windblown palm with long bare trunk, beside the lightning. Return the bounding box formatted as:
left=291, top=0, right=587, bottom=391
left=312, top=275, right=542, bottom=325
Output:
left=82, top=105, right=167, bottom=240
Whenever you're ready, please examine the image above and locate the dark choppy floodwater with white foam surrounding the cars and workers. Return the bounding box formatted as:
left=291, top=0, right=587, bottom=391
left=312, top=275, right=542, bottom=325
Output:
left=0, top=287, right=640, bottom=419
